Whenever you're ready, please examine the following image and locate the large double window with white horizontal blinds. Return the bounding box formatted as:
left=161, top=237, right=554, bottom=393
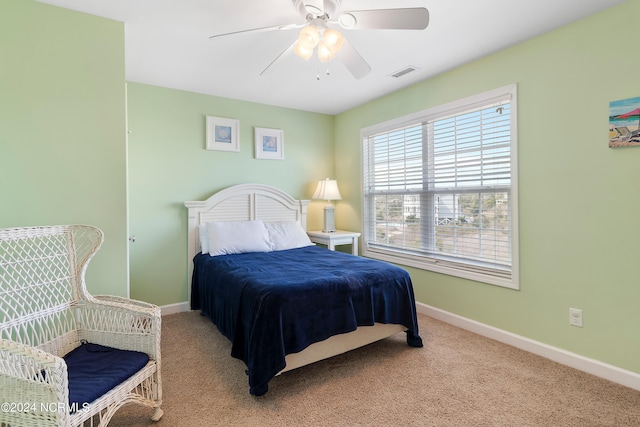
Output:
left=362, top=85, right=519, bottom=289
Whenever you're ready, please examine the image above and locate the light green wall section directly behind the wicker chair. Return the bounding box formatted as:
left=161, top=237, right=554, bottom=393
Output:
left=0, top=0, right=128, bottom=295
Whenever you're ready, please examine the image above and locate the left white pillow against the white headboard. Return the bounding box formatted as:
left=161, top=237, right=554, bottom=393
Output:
left=207, top=221, right=273, bottom=256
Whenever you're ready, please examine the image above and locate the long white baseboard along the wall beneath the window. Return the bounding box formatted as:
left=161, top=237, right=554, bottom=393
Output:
left=416, top=302, right=640, bottom=390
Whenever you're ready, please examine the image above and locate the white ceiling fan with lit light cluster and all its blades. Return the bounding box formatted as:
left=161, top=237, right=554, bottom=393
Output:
left=209, top=0, right=429, bottom=79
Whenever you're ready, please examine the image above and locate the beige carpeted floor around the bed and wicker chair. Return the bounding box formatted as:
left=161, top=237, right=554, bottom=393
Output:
left=110, top=312, right=640, bottom=427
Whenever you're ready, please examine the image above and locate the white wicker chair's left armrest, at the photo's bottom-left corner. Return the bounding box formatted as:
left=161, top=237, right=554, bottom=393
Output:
left=0, top=339, right=69, bottom=425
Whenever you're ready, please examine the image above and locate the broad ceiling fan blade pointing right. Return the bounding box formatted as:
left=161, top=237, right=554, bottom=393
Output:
left=338, top=7, right=429, bottom=30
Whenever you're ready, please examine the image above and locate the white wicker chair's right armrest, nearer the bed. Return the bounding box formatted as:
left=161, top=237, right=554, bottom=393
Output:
left=78, top=295, right=161, bottom=362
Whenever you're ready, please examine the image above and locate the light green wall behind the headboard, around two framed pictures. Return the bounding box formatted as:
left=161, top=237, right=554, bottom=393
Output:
left=127, top=83, right=334, bottom=305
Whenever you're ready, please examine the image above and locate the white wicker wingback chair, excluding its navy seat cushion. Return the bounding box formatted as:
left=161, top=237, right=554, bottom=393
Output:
left=0, top=225, right=162, bottom=427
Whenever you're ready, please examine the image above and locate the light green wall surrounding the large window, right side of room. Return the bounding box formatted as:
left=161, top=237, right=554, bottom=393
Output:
left=335, top=2, right=640, bottom=372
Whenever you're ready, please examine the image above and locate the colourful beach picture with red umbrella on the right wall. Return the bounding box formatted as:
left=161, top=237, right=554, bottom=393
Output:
left=609, top=96, right=640, bottom=148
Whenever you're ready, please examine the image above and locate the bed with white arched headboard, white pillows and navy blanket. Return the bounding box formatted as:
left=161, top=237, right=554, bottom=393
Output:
left=185, top=184, right=422, bottom=396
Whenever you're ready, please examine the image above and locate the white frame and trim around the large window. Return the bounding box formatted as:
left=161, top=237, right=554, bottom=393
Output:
left=360, top=84, right=520, bottom=290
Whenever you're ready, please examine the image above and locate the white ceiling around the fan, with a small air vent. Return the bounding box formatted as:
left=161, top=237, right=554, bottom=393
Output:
left=39, top=0, right=626, bottom=114
